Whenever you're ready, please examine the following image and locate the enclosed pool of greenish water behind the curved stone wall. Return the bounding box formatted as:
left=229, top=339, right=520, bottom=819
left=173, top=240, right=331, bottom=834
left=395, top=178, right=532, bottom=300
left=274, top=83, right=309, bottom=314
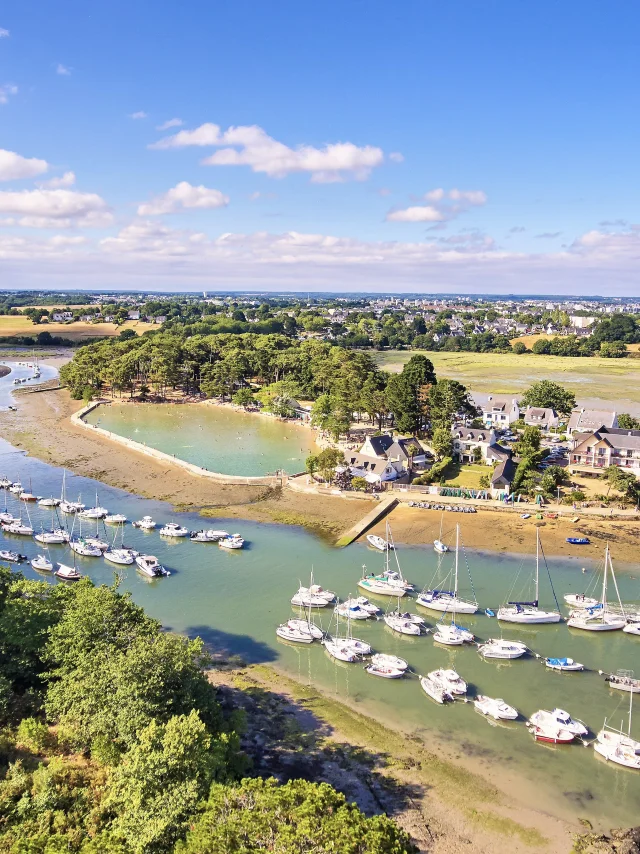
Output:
left=87, top=403, right=318, bottom=476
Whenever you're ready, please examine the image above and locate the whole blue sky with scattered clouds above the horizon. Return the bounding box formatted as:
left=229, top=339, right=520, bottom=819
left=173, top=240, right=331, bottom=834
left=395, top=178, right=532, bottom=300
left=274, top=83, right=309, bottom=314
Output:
left=0, top=0, right=640, bottom=294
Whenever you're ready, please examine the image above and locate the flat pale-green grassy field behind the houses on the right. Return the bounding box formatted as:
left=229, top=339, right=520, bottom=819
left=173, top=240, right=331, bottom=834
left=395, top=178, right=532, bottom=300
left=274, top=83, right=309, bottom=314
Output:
left=374, top=350, right=640, bottom=413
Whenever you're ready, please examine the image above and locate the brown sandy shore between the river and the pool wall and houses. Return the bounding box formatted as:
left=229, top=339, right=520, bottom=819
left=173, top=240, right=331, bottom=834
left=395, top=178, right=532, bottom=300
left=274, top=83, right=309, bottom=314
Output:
left=0, top=389, right=640, bottom=564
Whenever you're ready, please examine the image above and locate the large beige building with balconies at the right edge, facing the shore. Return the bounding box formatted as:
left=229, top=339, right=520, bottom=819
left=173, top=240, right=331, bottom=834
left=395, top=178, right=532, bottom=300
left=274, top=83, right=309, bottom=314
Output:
left=569, top=427, right=640, bottom=479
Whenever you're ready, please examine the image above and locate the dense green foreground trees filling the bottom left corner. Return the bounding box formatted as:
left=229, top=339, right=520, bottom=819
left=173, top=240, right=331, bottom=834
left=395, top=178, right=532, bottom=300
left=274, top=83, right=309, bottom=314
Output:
left=0, top=567, right=416, bottom=854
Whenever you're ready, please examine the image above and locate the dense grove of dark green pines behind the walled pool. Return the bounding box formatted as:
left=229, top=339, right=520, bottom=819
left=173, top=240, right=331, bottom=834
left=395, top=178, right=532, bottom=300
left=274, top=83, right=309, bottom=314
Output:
left=61, top=330, right=475, bottom=435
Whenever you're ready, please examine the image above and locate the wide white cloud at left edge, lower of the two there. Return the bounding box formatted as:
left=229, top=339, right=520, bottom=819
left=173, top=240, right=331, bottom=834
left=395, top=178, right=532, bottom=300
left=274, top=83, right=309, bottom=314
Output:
left=0, top=189, right=113, bottom=228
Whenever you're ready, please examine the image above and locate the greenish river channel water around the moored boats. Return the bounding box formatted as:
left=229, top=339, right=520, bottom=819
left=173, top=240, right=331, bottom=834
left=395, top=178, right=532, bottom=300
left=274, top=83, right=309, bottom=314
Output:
left=0, top=434, right=640, bottom=826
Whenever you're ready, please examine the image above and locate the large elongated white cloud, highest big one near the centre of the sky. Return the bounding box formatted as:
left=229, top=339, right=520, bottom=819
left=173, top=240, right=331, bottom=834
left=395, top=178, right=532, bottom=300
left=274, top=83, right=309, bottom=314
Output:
left=150, top=123, right=384, bottom=184
